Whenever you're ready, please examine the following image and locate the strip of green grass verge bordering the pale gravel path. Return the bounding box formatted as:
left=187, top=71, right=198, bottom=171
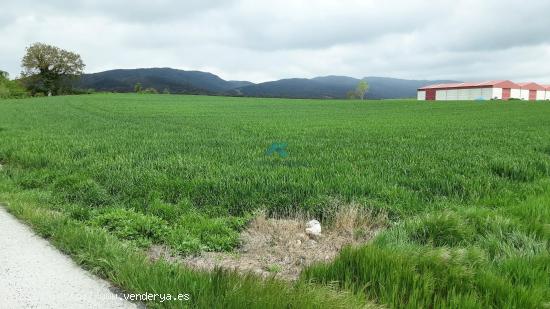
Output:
left=0, top=186, right=365, bottom=308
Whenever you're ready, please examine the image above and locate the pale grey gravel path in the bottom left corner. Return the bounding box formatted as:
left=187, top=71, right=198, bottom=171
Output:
left=0, top=206, right=137, bottom=309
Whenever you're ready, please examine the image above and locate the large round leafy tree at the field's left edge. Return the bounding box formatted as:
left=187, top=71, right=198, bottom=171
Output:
left=21, top=43, right=85, bottom=95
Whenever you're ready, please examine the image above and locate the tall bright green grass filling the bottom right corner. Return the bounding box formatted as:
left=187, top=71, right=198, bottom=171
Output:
left=302, top=189, right=550, bottom=308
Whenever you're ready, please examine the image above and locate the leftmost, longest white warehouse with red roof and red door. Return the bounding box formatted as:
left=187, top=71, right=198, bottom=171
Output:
left=418, top=80, right=521, bottom=101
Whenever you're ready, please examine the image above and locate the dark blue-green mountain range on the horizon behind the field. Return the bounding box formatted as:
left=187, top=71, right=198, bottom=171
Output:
left=76, top=68, right=453, bottom=99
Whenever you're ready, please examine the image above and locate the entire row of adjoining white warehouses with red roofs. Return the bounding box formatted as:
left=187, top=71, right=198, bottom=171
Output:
left=417, top=80, right=550, bottom=101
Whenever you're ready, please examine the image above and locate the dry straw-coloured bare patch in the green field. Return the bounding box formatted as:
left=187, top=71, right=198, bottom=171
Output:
left=149, top=208, right=387, bottom=280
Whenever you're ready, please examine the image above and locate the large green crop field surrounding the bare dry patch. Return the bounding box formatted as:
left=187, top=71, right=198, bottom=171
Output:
left=0, top=94, right=550, bottom=308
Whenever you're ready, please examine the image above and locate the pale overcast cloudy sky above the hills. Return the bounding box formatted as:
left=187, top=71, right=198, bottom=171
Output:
left=0, top=0, right=550, bottom=84
